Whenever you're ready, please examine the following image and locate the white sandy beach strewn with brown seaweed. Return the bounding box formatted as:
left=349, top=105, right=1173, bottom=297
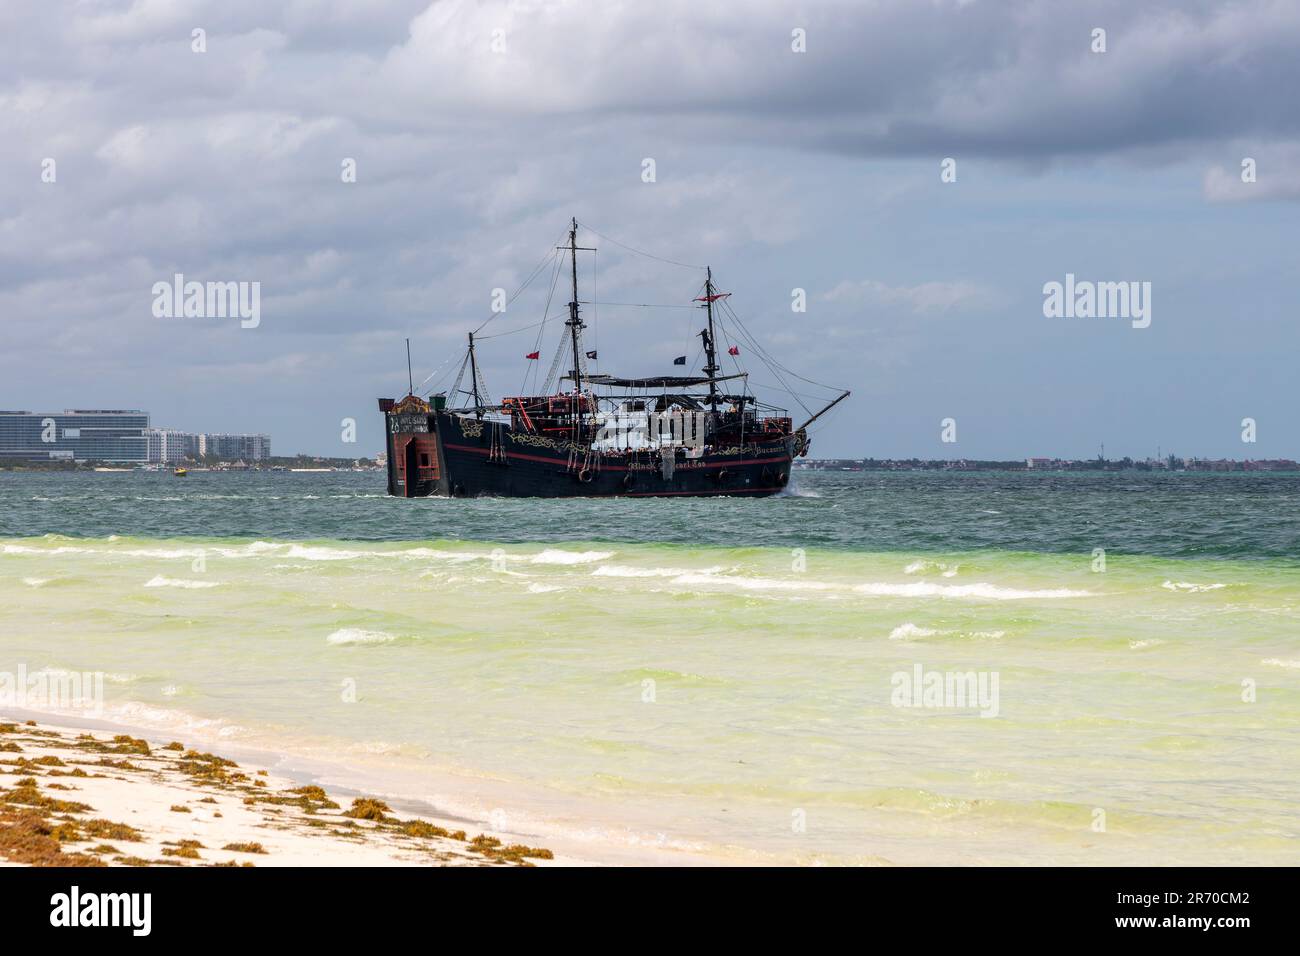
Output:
left=0, top=721, right=582, bottom=866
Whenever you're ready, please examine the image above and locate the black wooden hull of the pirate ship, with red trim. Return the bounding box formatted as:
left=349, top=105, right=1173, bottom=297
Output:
left=385, top=410, right=797, bottom=498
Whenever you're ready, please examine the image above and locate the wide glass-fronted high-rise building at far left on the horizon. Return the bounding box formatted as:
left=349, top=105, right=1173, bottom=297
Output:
left=0, top=408, right=150, bottom=463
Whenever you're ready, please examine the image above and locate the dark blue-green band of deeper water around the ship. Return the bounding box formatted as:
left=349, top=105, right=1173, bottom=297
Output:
left=0, top=472, right=1300, bottom=559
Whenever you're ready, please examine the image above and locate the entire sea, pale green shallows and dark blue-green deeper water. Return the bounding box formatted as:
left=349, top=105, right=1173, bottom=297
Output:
left=0, top=473, right=1300, bottom=865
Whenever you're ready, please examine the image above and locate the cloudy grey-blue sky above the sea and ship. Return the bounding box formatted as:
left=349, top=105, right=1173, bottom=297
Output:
left=0, top=0, right=1300, bottom=458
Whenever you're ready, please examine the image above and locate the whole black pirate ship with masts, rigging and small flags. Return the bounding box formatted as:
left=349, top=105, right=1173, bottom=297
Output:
left=378, top=219, right=849, bottom=498
